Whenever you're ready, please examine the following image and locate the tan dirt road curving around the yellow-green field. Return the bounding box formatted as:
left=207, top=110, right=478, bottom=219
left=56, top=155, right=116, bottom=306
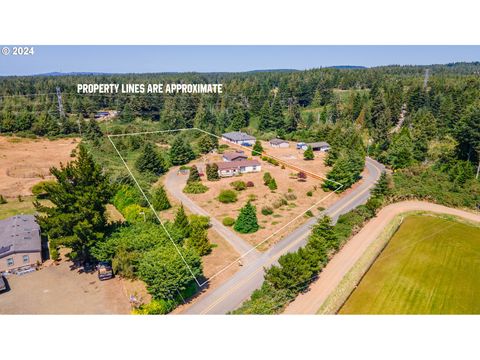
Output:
left=284, top=201, right=480, bottom=314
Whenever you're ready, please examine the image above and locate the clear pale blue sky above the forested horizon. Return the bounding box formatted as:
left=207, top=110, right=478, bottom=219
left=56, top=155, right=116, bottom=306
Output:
left=0, top=45, right=480, bottom=76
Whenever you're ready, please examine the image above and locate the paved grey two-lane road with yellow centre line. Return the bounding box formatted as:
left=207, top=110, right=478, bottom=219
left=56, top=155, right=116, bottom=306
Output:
left=185, top=158, right=384, bottom=314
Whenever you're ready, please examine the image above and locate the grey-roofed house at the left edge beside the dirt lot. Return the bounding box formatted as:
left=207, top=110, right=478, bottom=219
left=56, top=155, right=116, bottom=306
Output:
left=0, top=215, right=42, bottom=272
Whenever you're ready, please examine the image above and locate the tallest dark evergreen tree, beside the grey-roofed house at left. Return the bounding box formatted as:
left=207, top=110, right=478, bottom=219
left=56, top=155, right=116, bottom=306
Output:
left=34, top=145, right=113, bottom=260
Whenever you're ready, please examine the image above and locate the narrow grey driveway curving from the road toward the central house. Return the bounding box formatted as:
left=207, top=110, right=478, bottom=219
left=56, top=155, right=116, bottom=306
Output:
left=165, top=168, right=260, bottom=263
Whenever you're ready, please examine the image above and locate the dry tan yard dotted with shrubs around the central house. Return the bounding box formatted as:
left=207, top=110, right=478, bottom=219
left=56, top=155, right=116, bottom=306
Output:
left=187, top=141, right=338, bottom=245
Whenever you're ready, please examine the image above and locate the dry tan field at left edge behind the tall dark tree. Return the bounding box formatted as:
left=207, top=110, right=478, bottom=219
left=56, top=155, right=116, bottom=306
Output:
left=0, top=137, right=79, bottom=198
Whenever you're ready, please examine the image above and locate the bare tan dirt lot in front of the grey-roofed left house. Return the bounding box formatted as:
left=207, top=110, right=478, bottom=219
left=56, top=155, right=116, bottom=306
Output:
left=0, top=261, right=130, bottom=314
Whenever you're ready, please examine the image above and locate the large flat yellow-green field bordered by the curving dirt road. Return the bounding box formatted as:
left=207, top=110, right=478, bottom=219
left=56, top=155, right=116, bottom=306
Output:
left=339, top=215, right=480, bottom=314
